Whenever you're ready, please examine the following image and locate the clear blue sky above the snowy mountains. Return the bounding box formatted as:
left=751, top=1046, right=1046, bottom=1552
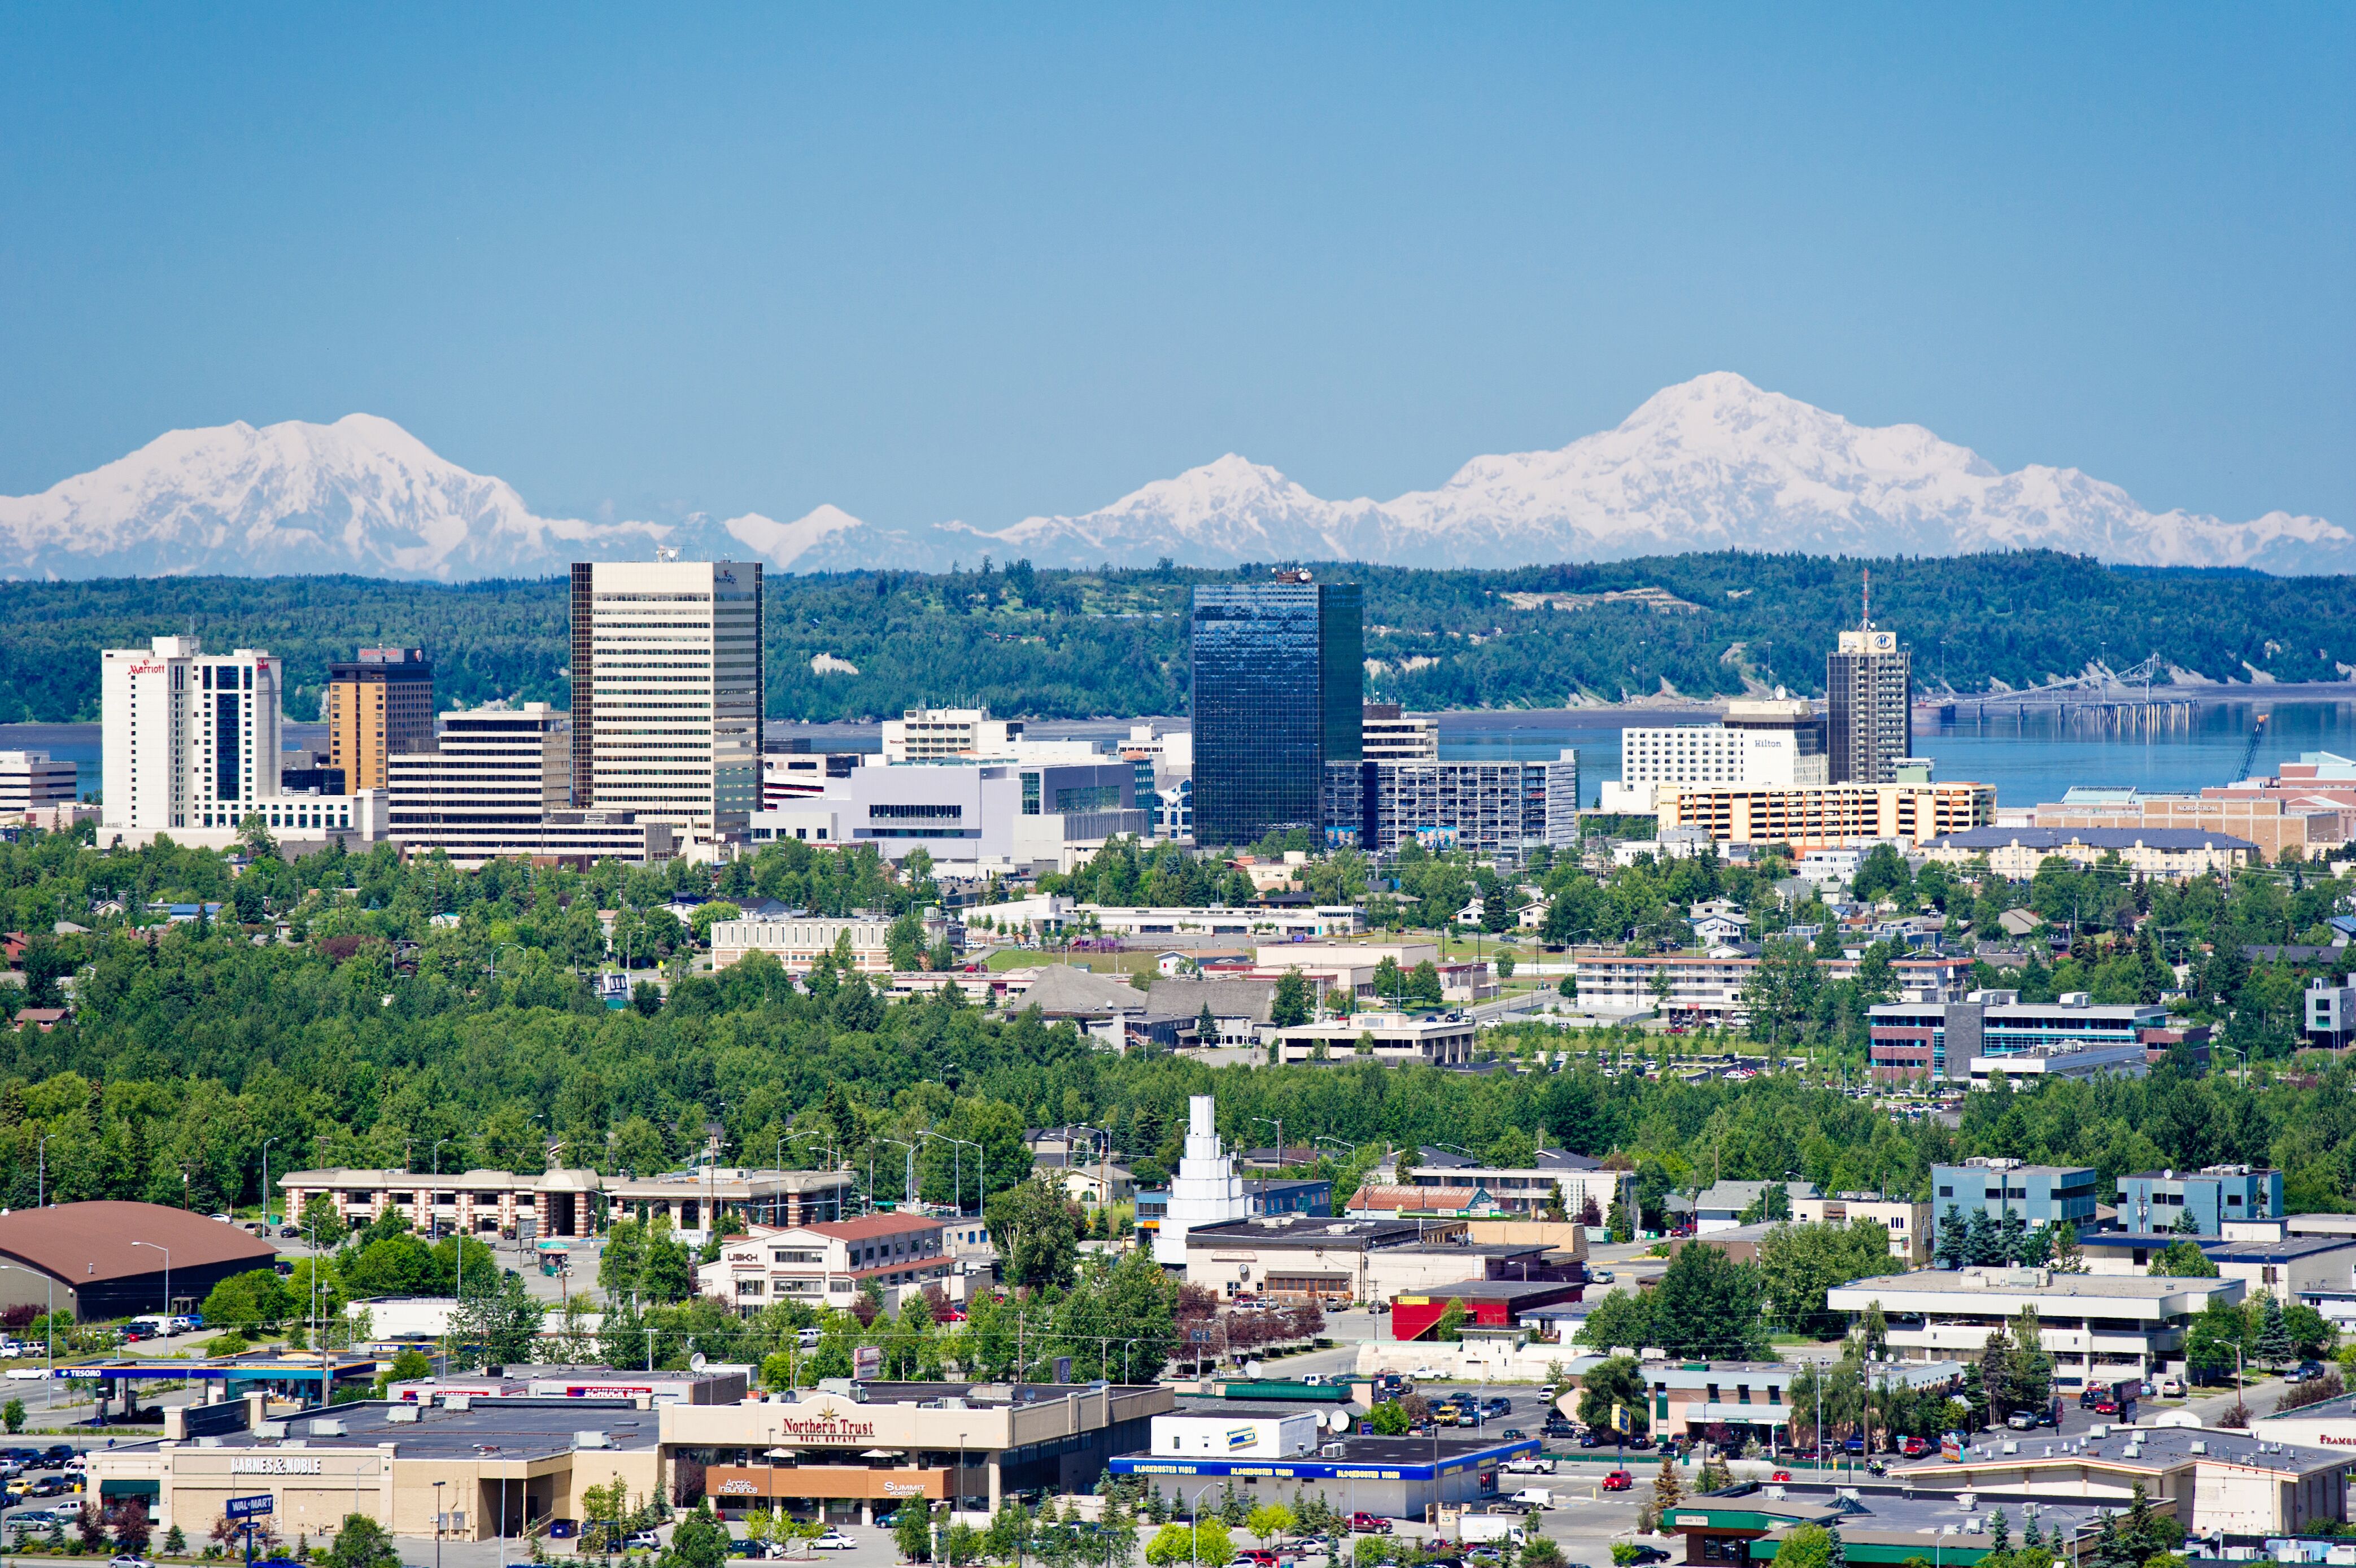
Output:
left=0, top=5, right=2356, bottom=525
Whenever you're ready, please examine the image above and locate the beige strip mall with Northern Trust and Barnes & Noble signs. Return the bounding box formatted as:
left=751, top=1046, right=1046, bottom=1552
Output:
left=90, top=1368, right=1173, bottom=1540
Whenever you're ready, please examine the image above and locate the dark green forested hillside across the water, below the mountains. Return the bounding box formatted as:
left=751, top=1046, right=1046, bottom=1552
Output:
left=0, top=553, right=2356, bottom=720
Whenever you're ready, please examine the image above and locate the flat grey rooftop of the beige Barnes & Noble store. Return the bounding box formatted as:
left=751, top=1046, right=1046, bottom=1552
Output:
left=113, top=1399, right=662, bottom=1460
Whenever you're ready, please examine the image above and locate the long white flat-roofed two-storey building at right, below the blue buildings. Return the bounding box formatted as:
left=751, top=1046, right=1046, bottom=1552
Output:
left=1826, top=1269, right=2243, bottom=1384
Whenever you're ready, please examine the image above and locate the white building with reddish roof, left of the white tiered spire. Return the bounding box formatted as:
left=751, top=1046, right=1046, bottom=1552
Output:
left=695, top=1215, right=957, bottom=1318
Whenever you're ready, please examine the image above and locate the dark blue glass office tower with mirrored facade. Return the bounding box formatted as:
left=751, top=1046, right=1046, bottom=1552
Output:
left=1190, top=570, right=1367, bottom=845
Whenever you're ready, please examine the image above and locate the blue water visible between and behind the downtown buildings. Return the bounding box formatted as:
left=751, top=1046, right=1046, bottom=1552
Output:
left=23, top=697, right=2356, bottom=805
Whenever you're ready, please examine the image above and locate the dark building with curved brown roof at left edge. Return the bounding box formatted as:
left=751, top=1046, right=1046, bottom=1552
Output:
left=0, top=1203, right=278, bottom=1323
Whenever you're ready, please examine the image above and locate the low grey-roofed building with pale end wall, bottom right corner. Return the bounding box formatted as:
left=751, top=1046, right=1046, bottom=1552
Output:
left=1892, top=1427, right=2356, bottom=1535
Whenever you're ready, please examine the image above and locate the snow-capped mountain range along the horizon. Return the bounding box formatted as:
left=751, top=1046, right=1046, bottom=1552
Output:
left=0, top=372, right=2356, bottom=582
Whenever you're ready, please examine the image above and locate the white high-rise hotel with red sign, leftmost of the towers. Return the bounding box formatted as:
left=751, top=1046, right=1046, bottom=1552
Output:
left=99, top=638, right=280, bottom=829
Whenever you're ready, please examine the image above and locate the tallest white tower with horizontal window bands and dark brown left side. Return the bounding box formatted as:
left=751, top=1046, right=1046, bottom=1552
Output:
left=573, top=558, right=761, bottom=831
